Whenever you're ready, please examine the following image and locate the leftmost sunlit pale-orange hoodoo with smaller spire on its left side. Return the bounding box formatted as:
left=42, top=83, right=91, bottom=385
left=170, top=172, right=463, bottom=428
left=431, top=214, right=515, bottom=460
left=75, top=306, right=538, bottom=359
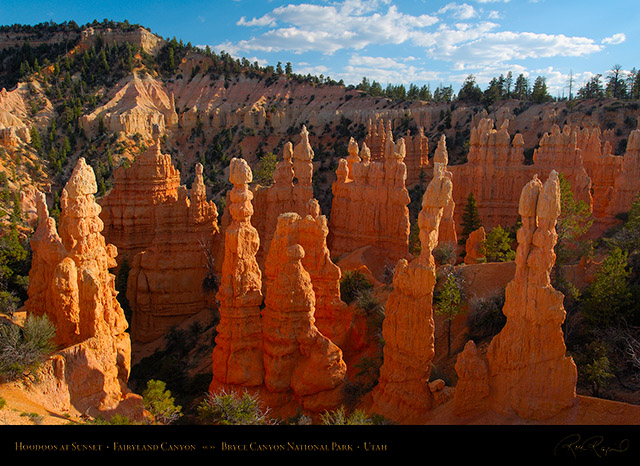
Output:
left=25, top=158, right=142, bottom=417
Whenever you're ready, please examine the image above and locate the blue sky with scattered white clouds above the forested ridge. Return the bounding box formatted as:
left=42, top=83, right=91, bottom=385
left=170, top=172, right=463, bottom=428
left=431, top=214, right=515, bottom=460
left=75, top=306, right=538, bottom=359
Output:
left=0, top=0, right=640, bottom=96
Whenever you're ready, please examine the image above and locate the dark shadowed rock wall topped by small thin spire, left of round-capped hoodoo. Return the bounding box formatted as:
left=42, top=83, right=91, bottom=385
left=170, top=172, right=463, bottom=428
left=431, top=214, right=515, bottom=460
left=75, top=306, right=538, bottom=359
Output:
left=127, top=164, right=218, bottom=342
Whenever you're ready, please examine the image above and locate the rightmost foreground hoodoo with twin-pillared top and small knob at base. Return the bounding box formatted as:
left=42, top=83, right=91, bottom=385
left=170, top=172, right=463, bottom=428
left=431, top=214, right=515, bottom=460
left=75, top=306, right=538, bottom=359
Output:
left=456, top=171, right=577, bottom=420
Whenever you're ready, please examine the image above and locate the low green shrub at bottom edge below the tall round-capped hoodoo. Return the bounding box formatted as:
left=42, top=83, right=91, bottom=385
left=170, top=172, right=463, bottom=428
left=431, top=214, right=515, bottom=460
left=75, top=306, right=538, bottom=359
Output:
left=198, top=390, right=271, bottom=425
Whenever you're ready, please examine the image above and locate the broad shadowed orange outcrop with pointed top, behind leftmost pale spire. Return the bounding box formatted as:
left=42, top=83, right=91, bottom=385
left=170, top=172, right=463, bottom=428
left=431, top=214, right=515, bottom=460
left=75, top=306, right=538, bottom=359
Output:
left=100, top=140, right=180, bottom=263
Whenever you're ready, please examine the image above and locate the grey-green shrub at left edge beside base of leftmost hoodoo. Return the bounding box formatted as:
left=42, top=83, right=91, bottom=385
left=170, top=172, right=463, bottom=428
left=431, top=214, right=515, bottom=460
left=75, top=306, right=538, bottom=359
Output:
left=0, top=315, right=55, bottom=380
